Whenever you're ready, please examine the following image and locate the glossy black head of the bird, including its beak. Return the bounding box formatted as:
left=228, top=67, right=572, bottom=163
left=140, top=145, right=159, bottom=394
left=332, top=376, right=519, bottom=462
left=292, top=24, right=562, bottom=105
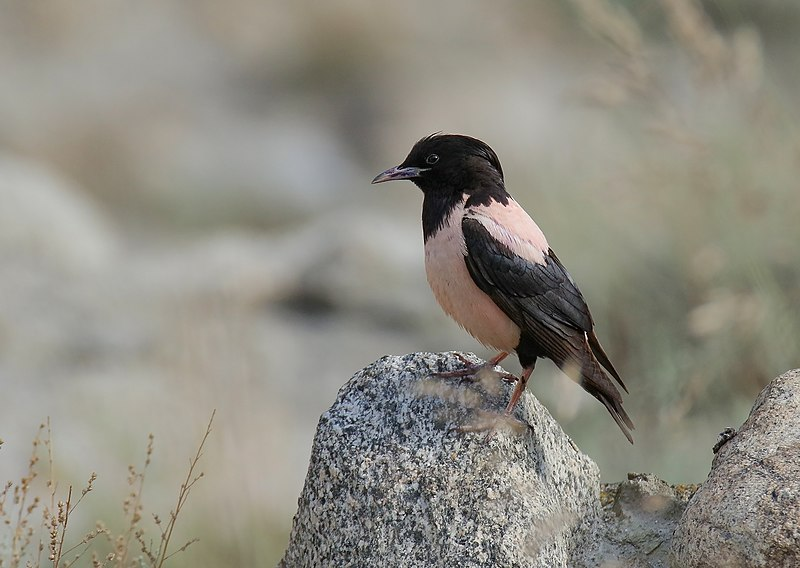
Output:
left=372, top=134, right=503, bottom=194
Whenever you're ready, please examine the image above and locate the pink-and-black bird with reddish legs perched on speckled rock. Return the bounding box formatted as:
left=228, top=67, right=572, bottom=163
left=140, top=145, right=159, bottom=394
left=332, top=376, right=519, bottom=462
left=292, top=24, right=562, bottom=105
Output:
left=372, top=133, right=634, bottom=444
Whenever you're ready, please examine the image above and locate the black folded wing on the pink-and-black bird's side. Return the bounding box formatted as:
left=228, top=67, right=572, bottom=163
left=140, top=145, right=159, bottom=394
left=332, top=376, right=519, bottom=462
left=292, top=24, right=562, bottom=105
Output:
left=461, top=217, right=627, bottom=391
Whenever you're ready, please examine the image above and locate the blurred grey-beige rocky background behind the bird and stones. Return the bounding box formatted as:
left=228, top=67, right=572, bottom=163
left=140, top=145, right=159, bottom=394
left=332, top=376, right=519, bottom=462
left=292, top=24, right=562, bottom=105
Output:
left=0, top=0, right=800, bottom=567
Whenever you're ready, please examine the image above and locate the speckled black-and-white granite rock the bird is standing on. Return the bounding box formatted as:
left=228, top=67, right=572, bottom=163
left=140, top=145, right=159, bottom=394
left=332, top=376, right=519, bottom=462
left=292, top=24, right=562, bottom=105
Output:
left=279, top=353, right=599, bottom=568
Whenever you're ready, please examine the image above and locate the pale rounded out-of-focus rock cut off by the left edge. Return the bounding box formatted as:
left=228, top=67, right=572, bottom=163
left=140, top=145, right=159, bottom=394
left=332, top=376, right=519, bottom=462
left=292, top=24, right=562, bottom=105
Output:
left=0, top=156, right=117, bottom=273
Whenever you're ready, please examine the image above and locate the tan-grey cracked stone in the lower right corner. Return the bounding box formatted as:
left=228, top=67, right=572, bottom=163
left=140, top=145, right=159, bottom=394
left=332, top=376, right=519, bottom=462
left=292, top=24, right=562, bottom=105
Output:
left=672, top=369, right=800, bottom=568
